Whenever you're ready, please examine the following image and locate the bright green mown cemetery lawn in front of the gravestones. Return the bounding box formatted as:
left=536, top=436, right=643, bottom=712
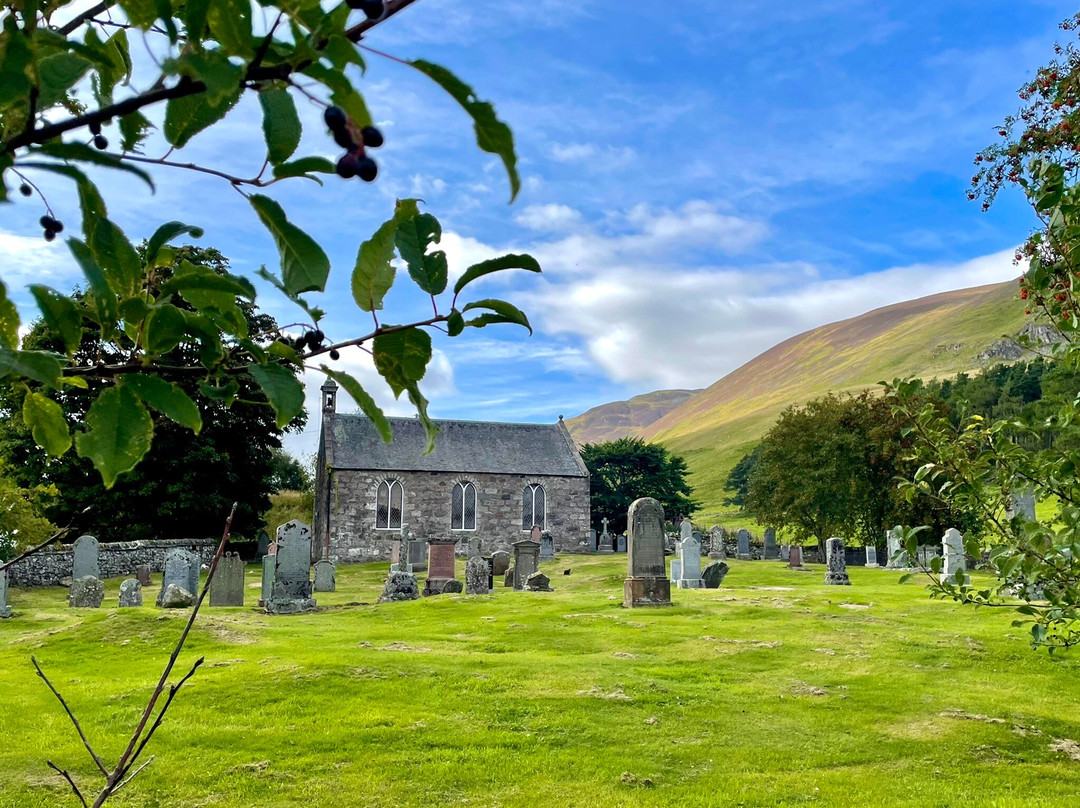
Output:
left=0, top=555, right=1080, bottom=808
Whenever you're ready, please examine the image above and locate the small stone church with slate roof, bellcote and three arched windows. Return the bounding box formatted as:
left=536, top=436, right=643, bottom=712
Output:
left=312, top=380, right=590, bottom=562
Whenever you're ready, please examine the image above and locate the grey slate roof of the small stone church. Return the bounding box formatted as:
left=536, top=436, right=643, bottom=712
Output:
left=324, top=414, right=589, bottom=477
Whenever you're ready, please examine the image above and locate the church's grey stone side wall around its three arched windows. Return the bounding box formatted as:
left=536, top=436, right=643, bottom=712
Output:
left=324, top=469, right=589, bottom=562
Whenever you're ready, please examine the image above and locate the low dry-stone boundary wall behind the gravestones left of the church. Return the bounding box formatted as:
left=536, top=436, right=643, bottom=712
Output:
left=8, top=539, right=217, bottom=587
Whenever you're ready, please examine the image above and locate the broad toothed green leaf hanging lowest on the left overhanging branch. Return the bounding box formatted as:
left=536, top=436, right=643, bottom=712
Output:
left=75, top=385, right=153, bottom=488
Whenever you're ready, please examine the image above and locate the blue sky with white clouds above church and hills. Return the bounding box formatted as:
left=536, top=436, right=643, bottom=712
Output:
left=0, top=0, right=1075, bottom=454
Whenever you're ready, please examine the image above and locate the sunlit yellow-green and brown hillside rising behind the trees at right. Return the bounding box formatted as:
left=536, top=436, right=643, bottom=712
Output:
left=638, top=283, right=1026, bottom=526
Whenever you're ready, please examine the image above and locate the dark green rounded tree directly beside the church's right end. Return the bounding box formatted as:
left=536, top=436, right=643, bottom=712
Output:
left=581, top=437, right=699, bottom=533
